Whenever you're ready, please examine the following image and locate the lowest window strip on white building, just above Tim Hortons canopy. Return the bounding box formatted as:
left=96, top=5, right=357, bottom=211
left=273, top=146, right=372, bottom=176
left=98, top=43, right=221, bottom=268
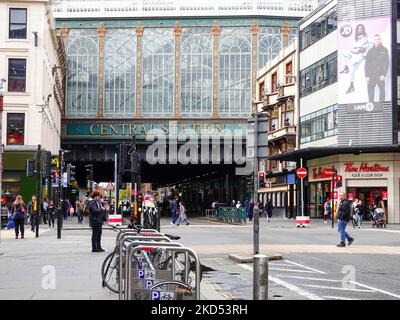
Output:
left=300, top=105, right=337, bottom=143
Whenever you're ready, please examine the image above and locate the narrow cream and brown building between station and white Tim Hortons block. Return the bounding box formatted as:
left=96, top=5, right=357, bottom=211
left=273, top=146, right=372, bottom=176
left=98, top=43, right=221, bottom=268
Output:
left=257, top=41, right=298, bottom=218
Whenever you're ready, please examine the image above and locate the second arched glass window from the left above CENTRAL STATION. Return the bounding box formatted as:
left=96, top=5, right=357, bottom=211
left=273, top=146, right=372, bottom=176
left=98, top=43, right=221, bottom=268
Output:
left=104, top=29, right=136, bottom=118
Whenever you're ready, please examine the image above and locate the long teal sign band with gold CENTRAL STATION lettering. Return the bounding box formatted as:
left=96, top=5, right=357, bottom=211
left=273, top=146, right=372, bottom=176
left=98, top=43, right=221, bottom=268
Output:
left=65, top=121, right=247, bottom=139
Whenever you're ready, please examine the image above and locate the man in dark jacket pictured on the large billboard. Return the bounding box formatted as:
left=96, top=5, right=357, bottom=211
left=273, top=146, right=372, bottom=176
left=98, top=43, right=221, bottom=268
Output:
left=364, top=34, right=389, bottom=103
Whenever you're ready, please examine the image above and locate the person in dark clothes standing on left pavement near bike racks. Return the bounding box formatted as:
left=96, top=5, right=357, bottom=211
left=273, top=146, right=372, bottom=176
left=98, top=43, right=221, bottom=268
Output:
left=89, top=191, right=105, bottom=252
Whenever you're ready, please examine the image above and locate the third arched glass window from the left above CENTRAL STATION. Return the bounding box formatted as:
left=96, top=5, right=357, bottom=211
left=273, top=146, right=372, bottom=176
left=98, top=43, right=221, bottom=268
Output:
left=142, top=28, right=175, bottom=117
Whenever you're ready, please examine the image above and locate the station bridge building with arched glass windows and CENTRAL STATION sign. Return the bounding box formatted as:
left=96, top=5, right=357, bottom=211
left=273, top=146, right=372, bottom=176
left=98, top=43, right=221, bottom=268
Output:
left=53, top=0, right=318, bottom=209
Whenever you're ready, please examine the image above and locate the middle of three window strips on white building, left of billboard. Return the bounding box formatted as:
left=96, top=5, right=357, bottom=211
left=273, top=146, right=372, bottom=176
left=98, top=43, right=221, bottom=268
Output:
left=300, top=52, right=337, bottom=97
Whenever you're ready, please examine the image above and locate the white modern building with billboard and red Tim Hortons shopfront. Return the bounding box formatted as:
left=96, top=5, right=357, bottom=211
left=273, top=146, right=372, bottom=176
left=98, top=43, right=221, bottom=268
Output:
left=270, top=0, right=400, bottom=223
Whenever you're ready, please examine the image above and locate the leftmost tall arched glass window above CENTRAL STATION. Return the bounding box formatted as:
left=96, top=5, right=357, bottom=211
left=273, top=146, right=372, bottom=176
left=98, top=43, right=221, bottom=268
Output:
left=66, top=29, right=99, bottom=118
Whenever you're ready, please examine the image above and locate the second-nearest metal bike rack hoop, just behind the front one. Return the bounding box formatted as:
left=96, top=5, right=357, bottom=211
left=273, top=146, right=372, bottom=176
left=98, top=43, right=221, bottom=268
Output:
left=124, top=241, right=183, bottom=300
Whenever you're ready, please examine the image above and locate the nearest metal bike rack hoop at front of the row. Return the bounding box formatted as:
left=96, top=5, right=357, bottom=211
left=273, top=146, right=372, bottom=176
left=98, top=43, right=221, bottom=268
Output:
left=125, top=243, right=200, bottom=300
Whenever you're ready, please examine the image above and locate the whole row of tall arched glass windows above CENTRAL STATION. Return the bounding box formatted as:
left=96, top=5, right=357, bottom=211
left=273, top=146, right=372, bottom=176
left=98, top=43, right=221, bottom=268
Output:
left=66, top=23, right=296, bottom=119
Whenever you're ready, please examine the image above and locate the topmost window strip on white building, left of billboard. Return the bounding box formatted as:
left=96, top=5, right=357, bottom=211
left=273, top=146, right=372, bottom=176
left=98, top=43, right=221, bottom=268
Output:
left=300, top=8, right=337, bottom=50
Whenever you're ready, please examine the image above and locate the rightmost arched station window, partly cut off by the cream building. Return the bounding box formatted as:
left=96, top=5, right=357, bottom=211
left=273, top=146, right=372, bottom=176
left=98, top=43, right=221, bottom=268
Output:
left=257, top=27, right=283, bottom=69
